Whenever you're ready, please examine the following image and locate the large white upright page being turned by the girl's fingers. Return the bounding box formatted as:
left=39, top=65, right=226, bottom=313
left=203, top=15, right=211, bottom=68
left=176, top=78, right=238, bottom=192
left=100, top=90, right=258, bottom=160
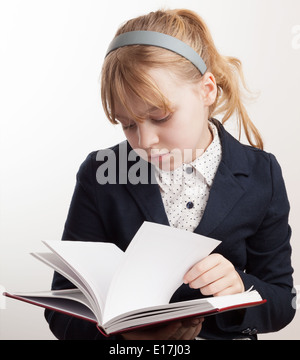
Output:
left=103, top=222, right=220, bottom=322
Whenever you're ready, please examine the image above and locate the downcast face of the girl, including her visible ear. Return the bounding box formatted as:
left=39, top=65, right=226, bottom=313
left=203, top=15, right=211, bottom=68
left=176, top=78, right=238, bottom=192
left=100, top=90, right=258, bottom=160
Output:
left=116, top=69, right=217, bottom=171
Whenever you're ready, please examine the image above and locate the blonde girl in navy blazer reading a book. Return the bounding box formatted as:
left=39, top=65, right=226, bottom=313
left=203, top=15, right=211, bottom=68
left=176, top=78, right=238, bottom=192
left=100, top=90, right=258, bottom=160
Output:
left=46, top=10, right=294, bottom=339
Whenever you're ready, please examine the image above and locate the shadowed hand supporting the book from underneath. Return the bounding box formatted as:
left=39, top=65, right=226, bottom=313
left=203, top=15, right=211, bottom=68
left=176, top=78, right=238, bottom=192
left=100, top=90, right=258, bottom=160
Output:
left=122, top=318, right=204, bottom=340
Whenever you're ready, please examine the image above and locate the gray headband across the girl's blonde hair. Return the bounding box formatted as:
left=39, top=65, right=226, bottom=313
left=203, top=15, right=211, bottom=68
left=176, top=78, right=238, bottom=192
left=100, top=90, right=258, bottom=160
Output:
left=105, top=31, right=207, bottom=75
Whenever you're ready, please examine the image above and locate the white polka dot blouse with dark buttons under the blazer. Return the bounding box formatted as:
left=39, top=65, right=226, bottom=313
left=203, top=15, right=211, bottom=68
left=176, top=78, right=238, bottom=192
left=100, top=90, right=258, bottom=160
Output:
left=155, top=123, right=222, bottom=231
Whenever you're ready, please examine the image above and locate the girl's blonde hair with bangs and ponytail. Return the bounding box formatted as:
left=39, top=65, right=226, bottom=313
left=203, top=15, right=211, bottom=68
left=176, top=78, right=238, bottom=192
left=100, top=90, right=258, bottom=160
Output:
left=101, top=9, right=263, bottom=149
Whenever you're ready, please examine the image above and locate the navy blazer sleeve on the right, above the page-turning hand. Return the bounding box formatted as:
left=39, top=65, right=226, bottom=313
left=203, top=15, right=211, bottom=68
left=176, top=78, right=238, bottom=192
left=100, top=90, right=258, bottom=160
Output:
left=216, top=154, right=295, bottom=334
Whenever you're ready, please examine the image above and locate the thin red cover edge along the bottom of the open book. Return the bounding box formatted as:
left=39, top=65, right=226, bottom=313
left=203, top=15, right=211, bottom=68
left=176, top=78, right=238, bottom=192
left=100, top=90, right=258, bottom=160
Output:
left=3, top=292, right=267, bottom=337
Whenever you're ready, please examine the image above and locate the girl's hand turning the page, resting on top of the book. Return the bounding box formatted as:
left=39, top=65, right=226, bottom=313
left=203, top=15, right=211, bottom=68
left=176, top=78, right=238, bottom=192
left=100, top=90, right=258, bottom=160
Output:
left=183, top=254, right=245, bottom=296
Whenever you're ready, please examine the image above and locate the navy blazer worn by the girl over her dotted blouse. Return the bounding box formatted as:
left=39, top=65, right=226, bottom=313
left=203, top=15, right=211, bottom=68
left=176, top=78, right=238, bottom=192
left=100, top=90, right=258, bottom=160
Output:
left=45, top=120, right=295, bottom=339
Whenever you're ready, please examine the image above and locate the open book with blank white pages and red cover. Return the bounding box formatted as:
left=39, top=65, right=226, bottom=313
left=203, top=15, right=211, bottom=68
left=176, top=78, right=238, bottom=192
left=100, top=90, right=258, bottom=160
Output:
left=5, top=222, right=264, bottom=335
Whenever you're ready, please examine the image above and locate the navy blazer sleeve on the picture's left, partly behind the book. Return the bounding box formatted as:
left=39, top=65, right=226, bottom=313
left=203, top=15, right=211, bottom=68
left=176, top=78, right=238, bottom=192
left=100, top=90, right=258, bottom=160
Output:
left=45, top=154, right=115, bottom=340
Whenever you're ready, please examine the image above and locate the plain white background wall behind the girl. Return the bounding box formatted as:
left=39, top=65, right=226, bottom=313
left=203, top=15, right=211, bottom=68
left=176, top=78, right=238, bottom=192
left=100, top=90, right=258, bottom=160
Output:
left=0, top=0, right=300, bottom=339
